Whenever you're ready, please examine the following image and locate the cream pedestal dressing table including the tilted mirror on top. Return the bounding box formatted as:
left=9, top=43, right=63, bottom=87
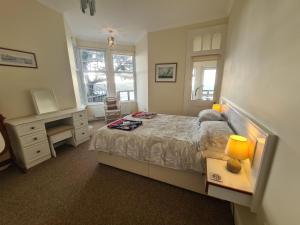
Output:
left=5, top=89, right=89, bottom=169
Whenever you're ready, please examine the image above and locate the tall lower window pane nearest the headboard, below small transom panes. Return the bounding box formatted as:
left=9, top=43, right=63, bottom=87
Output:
left=191, top=57, right=217, bottom=101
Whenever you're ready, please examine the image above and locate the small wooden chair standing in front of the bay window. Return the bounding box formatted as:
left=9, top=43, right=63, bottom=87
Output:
left=104, top=97, right=122, bottom=123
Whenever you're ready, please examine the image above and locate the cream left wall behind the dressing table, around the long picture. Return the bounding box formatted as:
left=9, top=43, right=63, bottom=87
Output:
left=0, top=0, right=75, bottom=118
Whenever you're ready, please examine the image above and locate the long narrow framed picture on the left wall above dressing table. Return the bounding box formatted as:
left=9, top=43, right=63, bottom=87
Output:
left=0, top=47, right=37, bottom=68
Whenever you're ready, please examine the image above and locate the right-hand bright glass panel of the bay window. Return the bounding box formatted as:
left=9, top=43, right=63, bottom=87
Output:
left=112, top=54, right=135, bottom=101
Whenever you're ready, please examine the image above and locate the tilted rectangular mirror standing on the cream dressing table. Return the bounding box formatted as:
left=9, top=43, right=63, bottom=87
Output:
left=30, top=89, right=58, bottom=114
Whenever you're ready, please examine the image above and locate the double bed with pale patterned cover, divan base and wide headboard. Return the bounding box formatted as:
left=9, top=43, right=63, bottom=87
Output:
left=90, top=99, right=276, bottom=211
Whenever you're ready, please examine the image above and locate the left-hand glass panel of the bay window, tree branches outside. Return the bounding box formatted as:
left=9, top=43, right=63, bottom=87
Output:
left=80, top=49, right=107, bottom=103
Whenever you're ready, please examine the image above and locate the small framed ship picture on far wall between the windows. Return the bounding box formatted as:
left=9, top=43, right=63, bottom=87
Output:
left=155, top=63, right=177, bottom=82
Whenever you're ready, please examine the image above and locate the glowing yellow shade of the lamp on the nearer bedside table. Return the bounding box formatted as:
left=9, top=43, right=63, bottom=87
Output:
left=225, top=135, right=249, bottom=160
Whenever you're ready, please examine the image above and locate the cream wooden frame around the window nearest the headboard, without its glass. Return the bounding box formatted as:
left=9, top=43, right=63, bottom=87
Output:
left=184, top=25, right=226, bottom=114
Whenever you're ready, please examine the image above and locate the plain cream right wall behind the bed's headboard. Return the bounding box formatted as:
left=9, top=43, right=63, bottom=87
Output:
left=222, top=0, right=300, bottom=225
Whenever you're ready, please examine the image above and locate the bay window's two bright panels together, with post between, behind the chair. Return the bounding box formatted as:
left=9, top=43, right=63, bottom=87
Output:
left=79, top=48, right=135, bottom=104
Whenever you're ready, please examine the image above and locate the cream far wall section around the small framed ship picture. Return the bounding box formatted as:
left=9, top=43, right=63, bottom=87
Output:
left=148, top=18, right=227, bottom=115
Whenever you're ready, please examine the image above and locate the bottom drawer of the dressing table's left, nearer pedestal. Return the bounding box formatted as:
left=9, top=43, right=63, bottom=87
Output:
left=23, top=142, right=50, bottom=163
